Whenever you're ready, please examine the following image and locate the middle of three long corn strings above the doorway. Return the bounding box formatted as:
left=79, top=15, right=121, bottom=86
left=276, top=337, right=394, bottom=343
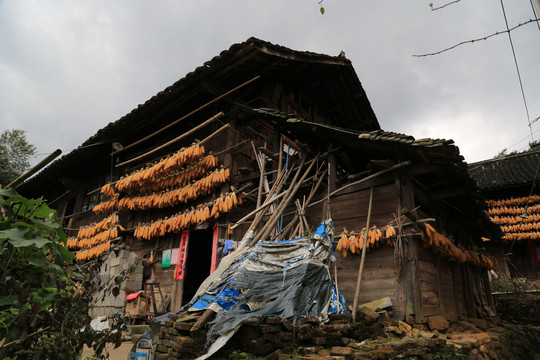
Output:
left=118, top=168, right=230, bottom=210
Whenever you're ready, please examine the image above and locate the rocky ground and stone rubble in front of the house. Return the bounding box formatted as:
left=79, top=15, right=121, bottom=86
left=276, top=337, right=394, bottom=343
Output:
left=150, top=308, right=540, bottom=360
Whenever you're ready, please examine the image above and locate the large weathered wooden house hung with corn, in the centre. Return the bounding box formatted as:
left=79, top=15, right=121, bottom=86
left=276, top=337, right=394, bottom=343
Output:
left=20, top=38, right=498, bottom=322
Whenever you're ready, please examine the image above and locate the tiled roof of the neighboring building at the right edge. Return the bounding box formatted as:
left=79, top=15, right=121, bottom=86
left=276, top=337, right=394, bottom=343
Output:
left=469, top=151, right=540, bottom=190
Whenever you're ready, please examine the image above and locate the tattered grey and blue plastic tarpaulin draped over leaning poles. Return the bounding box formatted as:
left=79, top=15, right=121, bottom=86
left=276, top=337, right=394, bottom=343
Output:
left=184, top=220, right=339, bottom=358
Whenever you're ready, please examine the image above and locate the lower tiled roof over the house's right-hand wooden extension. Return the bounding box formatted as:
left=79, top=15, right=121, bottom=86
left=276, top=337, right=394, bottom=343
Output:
left=255, top=109, right=501, bottom=239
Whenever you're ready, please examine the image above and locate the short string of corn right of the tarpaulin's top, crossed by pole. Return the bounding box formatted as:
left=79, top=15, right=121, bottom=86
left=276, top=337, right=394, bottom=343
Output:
left=336, top=225, right=396, bottom=257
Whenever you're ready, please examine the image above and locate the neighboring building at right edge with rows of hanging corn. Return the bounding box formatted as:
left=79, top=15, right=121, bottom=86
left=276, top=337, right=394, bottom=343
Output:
left=469, top=150, right=540, bottom=280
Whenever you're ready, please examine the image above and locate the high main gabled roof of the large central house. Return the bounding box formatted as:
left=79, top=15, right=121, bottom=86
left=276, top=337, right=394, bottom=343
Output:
left=19, top=38, right=380, bottom=192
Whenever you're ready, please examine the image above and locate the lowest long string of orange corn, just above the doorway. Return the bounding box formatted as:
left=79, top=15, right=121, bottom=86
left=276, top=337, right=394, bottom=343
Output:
left=133, top=192, right=242, bottom=240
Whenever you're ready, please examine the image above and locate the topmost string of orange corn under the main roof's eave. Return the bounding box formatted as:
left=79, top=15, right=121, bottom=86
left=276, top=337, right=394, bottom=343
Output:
left=115, top=143, right=206, bottom=191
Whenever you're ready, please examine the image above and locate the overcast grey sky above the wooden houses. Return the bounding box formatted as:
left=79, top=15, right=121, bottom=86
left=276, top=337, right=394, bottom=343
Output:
left=0, top=0, right=540, bottom=163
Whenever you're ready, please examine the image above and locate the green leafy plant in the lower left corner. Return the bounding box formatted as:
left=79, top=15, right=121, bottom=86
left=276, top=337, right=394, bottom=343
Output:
left=0, top=189, right=121, bottom=359
